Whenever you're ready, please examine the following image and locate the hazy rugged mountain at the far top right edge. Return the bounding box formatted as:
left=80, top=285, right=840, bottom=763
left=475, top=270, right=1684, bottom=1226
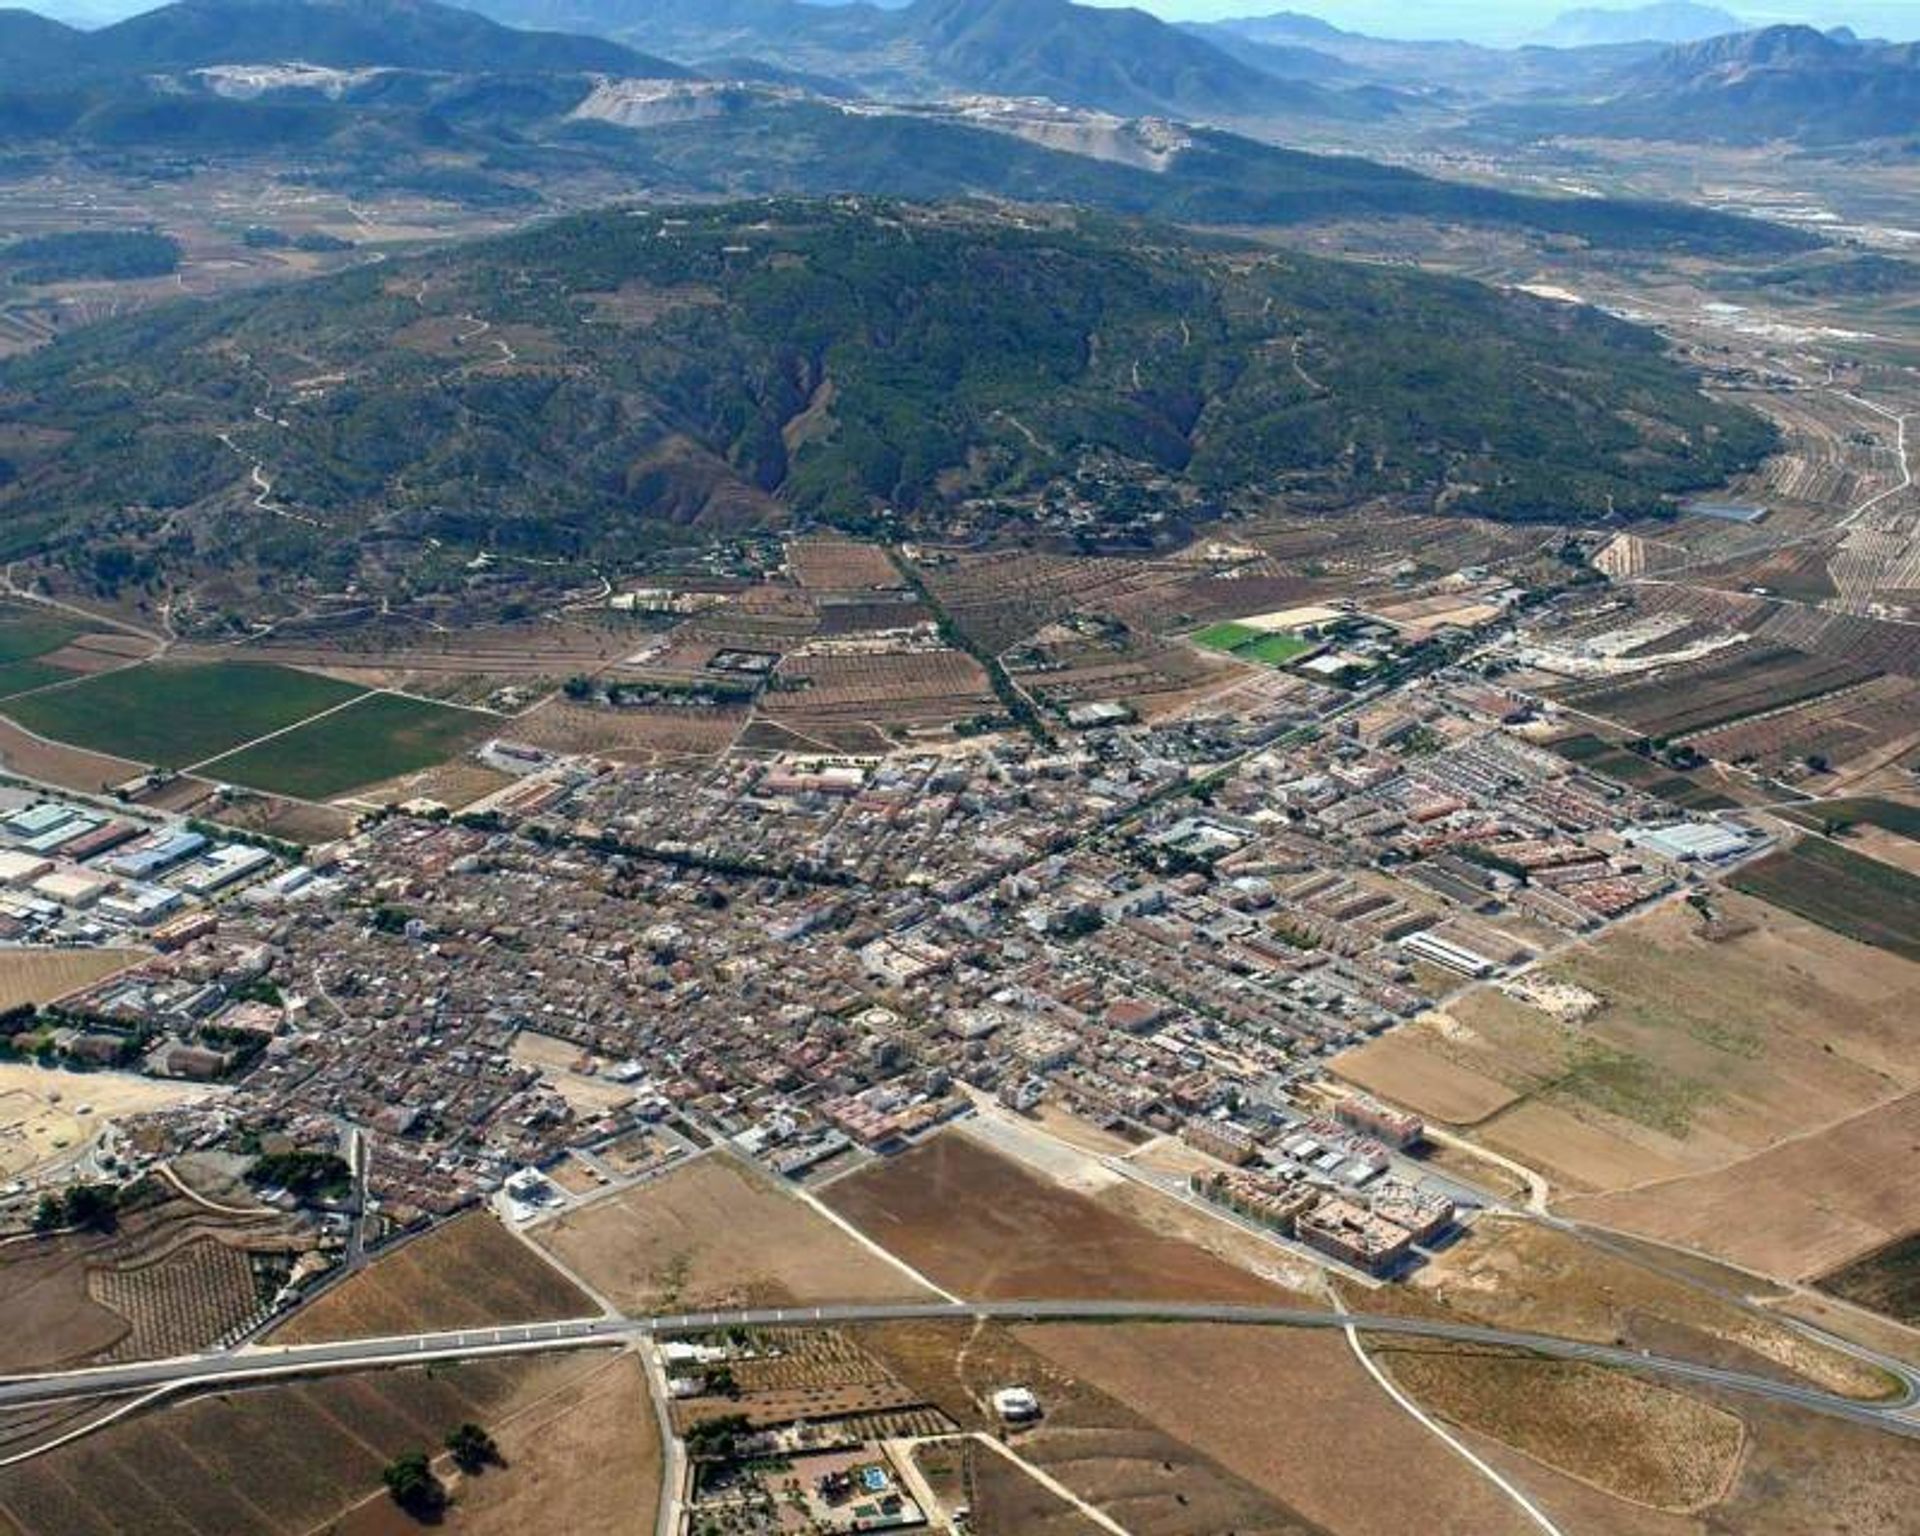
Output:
left=1486, top=27, right=1920, bottom=148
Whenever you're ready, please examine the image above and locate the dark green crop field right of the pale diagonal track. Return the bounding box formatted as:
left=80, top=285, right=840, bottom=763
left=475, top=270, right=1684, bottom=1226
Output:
left=205, top=693, right=497, bottom=801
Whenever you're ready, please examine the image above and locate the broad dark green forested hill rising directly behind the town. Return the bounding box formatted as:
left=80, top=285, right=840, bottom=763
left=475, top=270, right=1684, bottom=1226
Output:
left=0, top=202, right=1768, bottom=599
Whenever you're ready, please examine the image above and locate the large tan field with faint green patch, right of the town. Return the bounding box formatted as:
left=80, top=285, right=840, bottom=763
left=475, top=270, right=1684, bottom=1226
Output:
left=1334, top=893, right=1920, bottom=1250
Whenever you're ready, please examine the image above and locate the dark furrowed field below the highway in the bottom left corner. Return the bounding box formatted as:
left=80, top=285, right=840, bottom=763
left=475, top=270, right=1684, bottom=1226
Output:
left=0, top=1354, right=602, bottom=1536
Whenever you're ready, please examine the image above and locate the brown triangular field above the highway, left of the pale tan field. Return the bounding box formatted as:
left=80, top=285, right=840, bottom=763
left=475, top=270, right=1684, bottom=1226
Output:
left=273, top=1212, right=597, bottom=1344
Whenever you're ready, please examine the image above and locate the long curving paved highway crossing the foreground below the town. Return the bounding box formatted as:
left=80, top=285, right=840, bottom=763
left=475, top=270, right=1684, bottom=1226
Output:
left=0, top=1302, right=1920, bottom=1438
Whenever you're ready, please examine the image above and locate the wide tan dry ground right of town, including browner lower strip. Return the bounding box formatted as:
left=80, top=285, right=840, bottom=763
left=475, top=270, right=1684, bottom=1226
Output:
left=1336, top=893, right=1920, bottom=1275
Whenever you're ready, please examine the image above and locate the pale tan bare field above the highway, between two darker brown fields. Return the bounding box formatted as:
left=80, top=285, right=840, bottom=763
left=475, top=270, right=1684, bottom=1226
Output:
left=532, top=1154, right=925, bottom=1311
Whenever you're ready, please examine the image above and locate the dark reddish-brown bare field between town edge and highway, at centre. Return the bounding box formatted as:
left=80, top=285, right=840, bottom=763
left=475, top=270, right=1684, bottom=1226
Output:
left=826, top=1131, right=1288, bottom=1302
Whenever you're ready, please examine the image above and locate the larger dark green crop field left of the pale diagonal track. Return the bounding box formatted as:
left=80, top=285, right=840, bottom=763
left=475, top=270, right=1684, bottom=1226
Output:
left=8, top=660, right=363, bottom=768
